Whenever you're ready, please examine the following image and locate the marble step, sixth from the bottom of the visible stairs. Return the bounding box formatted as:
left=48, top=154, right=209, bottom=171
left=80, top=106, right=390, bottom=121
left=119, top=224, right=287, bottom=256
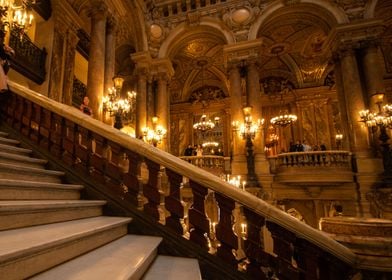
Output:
left=0, top=163, right=65, bottom=183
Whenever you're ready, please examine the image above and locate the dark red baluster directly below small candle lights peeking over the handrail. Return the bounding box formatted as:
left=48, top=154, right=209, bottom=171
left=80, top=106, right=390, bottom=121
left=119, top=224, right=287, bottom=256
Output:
left=215, top=193, right=238, bottom=268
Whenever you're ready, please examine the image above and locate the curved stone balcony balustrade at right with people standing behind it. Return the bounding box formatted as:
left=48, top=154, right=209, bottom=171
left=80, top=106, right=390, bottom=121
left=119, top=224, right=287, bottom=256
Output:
left=269, top=150, right=351, bottom=173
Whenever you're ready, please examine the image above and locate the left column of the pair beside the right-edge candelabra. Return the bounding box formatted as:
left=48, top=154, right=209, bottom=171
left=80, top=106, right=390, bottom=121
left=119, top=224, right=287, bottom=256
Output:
left=340, top=48, right=371, bottom=157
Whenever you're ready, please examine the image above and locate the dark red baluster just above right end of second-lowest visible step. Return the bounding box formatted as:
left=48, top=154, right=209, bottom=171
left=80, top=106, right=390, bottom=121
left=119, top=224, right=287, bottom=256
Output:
left=143, top=159, right=161, bottom=221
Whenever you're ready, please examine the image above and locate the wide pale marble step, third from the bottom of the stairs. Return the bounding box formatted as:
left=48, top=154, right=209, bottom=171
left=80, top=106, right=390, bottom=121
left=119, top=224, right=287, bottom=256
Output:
left=0, top=216, right=131, bottom=280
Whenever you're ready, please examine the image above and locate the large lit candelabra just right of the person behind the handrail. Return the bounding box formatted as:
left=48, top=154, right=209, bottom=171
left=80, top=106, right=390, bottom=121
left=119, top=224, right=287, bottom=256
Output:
left=102, top=77, right=136, bottom=129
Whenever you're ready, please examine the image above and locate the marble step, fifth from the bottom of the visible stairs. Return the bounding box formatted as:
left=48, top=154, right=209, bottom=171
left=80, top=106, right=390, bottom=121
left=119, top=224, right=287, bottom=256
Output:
left=0, top=179, right=83, bottom=200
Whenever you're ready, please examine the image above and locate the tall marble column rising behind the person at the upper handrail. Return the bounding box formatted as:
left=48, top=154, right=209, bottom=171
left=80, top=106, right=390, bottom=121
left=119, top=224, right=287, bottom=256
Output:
left=87, top=2, right=107, bottom=120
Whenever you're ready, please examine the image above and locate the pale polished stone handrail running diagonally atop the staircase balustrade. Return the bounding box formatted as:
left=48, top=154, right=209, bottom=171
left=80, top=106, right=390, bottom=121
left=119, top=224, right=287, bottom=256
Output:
left=9, top=81, right=363, bottom=266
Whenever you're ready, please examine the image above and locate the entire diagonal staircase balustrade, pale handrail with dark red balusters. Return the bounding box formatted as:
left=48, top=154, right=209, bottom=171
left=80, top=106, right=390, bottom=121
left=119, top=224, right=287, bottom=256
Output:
left=0, top=82, right=382, bottom=279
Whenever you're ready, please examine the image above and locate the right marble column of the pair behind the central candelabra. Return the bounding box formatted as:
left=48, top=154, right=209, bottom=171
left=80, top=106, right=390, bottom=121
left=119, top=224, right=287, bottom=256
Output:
left=247, top=61, right=269, bottom=174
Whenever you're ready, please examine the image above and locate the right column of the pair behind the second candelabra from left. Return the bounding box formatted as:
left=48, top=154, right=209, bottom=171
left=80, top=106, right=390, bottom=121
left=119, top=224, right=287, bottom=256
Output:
left=156, top=73, right=170, bottom=151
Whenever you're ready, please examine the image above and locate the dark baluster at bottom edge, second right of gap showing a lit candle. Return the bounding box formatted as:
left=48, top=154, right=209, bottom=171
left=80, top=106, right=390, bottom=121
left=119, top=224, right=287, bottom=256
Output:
left=266, top=221, right=299, bottom=280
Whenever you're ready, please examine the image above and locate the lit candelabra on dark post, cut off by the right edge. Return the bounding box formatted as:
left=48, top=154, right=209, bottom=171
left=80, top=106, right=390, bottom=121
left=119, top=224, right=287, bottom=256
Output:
left=359, top=93, right=392, bottom=178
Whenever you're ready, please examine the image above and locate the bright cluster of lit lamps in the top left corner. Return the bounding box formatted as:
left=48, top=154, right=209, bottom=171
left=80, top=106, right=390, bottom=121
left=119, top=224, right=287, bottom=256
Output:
left=0, top=0, right=36, bottom=37
